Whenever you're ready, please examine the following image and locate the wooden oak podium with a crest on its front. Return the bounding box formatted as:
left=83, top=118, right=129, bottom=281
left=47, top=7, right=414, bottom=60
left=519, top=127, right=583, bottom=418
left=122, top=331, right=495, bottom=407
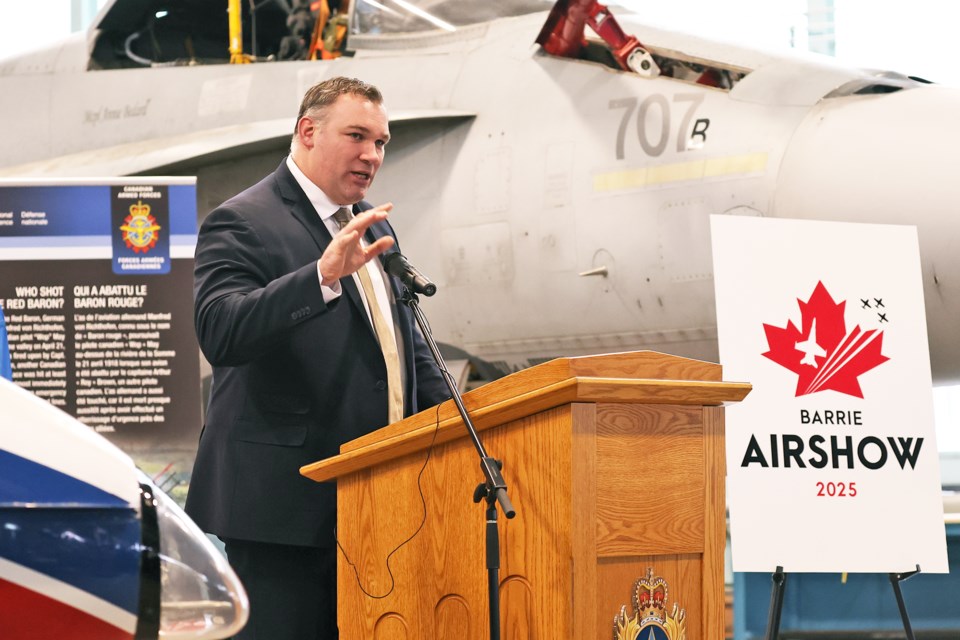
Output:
left=301, top=352, right=750, bottom=640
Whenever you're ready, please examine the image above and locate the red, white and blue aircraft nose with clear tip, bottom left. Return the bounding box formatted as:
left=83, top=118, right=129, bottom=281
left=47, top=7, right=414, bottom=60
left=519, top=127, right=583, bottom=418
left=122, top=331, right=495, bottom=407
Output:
left=0, top=378, right=249, bottom=640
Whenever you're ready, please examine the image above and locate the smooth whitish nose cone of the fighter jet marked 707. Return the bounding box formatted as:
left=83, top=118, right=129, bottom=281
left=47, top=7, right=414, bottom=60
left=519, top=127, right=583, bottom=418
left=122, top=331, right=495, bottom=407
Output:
left=771, top=86, right=960, bottom=381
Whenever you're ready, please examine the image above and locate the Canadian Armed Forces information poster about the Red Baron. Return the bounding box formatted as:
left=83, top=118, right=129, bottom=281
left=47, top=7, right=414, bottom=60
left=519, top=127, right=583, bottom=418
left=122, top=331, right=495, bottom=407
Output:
left=0, top=178, right=201, bottom=453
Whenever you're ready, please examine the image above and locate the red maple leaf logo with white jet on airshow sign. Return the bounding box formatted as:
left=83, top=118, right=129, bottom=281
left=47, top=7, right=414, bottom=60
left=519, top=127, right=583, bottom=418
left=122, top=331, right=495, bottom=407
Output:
left=763, top=282, right=890, bottom=398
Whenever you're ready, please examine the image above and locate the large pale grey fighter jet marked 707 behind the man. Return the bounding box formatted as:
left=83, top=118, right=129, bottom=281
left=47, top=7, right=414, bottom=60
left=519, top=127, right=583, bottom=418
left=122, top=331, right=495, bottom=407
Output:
left=0, top=0, right=960, bottom=383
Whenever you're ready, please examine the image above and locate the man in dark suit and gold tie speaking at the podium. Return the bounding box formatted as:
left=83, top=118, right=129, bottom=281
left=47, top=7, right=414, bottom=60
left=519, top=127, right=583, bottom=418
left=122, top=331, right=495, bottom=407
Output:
left=187, top=78, right=448, bottom=640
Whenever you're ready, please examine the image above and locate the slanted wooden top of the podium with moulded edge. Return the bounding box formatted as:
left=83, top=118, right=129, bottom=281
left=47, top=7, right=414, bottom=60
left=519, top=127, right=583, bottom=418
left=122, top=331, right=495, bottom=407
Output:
left=300, top=351, right=751, bottom=482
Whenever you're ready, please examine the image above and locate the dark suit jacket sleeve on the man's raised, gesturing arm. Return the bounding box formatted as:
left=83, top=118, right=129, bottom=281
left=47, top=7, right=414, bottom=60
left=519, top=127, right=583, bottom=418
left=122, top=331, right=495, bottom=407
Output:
left=194, top=207, right=327, bottom=366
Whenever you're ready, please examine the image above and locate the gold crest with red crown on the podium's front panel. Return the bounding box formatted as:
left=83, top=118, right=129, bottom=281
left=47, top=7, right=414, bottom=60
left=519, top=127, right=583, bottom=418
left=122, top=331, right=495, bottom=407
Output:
left=613, top=568, right=687, bottom=640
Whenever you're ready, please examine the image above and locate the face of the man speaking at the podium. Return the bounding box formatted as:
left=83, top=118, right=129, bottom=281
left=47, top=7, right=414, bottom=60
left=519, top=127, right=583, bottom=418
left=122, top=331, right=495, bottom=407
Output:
left=305, top=94, right=390, bottom=204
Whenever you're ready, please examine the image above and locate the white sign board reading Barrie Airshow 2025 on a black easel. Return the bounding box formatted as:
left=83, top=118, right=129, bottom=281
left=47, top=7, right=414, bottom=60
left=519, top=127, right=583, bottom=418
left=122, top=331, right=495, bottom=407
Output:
left=711, top=216, right=948, bottom=573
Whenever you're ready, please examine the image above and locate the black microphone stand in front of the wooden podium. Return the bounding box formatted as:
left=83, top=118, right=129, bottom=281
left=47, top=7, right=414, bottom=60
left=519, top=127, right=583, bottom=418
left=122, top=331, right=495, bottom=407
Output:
left=400, top=286, right=517, bottom=640
